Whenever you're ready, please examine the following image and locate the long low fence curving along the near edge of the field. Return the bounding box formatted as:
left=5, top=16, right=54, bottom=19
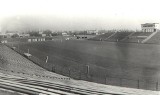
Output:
left=4, top=44, right=160, bottom=91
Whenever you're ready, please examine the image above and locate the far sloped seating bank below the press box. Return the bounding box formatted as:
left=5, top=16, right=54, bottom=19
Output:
left=89, top=32, right=160, bottom=44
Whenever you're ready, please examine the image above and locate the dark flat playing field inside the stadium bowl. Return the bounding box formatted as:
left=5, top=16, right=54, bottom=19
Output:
left=11, top=40, right=160, bottom=90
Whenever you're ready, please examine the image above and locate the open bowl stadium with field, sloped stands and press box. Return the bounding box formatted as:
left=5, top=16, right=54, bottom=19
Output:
left=0, top=23, right=160, bottom=95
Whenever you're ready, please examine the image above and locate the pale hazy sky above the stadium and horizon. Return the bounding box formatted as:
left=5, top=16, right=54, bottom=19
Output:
left=0, top=0, right=160, bottom=31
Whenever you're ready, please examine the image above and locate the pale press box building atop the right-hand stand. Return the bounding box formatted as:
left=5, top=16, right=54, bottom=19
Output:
left=141, top=23, right=159, bottom=32
